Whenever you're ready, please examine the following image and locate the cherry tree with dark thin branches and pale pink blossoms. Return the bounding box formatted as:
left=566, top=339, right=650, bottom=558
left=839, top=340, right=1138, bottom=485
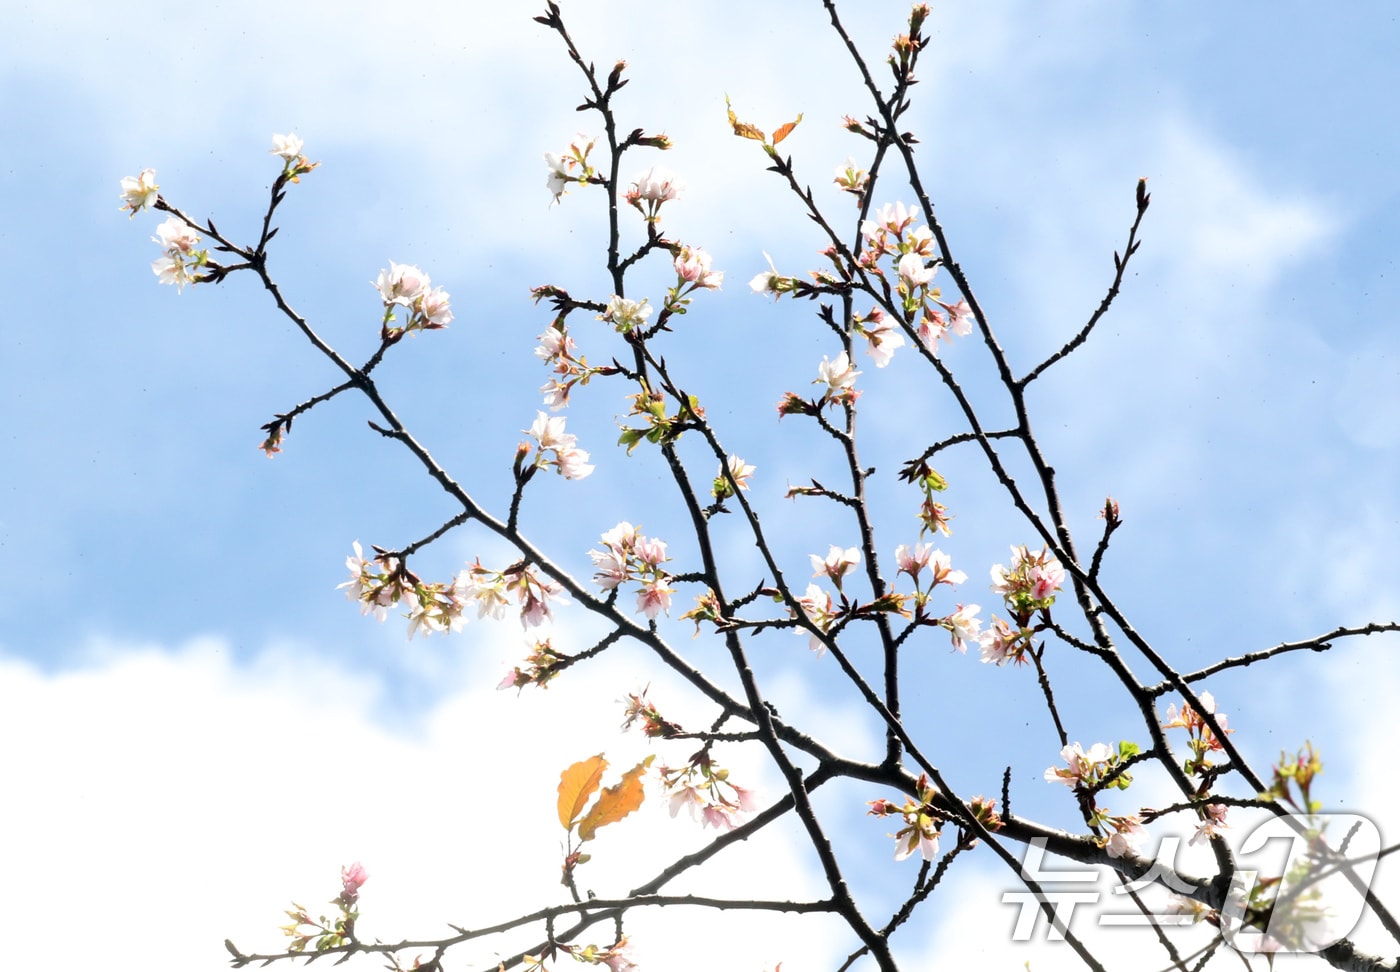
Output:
left=122, top=0, right=1400, bottom=972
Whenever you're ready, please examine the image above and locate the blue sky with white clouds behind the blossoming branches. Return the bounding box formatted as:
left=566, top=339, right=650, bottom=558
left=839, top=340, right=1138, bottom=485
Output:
left=0, top=0, right=1400, bottom=972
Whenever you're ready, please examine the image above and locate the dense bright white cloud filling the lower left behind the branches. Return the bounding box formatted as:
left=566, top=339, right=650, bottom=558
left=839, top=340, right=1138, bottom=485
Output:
left=0, top=639, right=862, bottom=972
